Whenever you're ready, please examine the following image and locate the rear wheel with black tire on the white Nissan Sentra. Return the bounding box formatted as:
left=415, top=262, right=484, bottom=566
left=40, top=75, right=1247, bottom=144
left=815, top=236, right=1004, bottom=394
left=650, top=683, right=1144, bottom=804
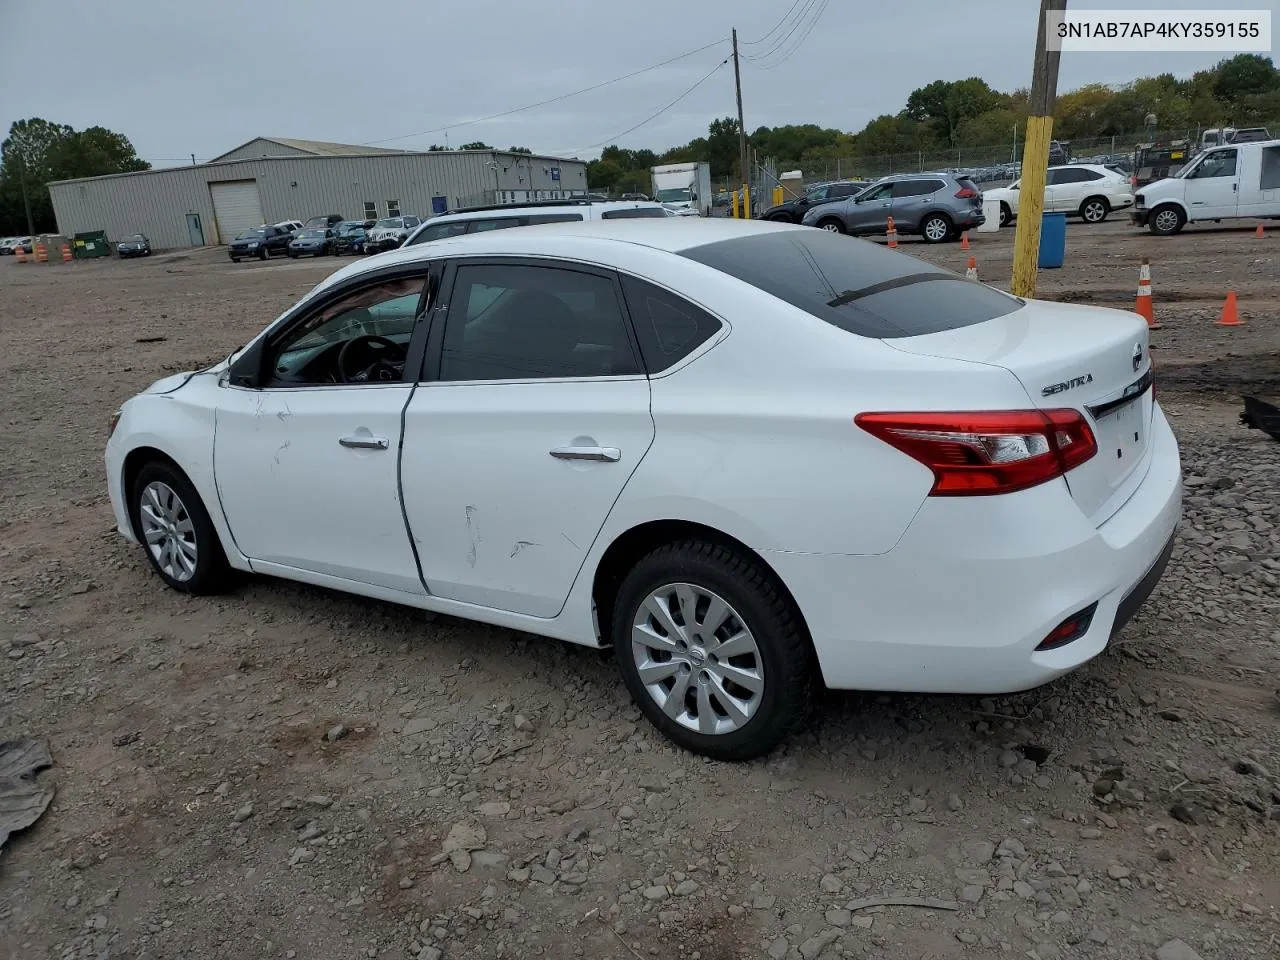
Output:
left=612, top=540, right=813, bottom=760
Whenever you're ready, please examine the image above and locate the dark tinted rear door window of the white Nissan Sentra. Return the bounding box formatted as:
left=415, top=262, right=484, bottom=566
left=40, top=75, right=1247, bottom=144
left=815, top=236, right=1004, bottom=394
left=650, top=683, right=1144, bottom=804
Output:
left=440, top=264, right=640, bottom=380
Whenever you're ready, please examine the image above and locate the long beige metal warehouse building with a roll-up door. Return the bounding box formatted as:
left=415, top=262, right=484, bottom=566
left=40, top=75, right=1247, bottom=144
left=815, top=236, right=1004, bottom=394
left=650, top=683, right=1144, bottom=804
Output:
left=49, top=137, right=586, bottom=248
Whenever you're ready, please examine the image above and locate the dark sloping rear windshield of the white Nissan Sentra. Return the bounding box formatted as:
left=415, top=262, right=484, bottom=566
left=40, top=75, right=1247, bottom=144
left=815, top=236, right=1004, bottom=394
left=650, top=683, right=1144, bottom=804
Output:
left=682, top=229, right=1023, bottom=338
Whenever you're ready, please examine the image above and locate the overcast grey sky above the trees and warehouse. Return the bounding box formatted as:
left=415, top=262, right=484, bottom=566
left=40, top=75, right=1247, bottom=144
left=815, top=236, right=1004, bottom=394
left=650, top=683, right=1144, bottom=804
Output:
left=0, top=0, right=1280, bottom=166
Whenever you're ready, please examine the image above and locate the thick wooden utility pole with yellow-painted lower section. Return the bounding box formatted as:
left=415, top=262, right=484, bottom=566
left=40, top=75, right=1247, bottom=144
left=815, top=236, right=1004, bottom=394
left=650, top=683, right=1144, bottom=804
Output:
left=1010, top=0, right=1066, bottom=297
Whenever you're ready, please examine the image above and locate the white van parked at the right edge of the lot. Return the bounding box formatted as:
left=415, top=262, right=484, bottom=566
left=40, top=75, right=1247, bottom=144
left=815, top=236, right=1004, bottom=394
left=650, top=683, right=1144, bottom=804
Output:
left=1133, top=140, right=1280, bottom=237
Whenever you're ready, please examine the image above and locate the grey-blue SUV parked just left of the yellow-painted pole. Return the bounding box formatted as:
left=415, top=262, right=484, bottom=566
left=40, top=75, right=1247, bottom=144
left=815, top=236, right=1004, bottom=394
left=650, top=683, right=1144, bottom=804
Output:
left=801, top=173, right=987, bottom=243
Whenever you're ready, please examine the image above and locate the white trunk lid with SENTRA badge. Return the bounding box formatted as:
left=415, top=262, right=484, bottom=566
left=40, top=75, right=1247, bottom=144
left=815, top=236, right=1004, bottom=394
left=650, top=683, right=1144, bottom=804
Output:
left=884, top=301, right=1155, bottom=525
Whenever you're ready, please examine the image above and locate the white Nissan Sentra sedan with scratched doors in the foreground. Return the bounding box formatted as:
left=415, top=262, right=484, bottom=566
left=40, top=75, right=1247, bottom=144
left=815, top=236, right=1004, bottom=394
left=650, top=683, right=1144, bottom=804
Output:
left=106, top=219, right=1181, bottom=759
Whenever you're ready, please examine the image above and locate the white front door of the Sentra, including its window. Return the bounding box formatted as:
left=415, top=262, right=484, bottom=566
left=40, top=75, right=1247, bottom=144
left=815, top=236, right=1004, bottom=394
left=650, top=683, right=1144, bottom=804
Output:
left=214, top=271, right=437, bottom=595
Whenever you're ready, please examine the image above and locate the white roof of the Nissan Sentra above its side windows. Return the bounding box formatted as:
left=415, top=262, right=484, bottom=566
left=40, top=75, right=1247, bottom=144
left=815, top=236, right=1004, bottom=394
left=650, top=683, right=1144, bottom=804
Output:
left=317, top=216, right=813, bottom=289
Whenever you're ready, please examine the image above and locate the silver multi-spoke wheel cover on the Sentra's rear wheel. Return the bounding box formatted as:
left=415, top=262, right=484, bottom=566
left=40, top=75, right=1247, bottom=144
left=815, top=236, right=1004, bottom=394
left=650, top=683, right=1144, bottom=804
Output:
left=631, top=584, right=764, bottom=736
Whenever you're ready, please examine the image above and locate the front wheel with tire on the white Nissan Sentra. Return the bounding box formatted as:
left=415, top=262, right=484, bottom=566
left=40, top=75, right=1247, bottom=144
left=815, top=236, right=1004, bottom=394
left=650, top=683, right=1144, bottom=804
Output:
left=129, top=461, right=232, bottom=595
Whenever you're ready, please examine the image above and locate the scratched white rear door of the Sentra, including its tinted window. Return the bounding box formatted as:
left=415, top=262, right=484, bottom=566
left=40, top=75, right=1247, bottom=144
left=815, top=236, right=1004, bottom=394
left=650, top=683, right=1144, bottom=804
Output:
left=401, top=260, right=654, bottom=617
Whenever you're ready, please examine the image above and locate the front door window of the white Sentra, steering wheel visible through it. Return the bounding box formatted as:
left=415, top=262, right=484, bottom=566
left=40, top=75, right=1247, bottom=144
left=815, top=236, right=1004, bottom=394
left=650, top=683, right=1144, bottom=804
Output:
left=268, top=273, right=425, bottom=387
